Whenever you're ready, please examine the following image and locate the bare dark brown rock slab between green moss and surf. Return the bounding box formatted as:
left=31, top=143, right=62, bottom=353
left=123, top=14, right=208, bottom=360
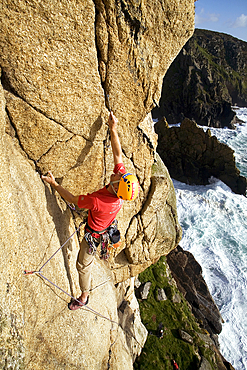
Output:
left=167, top=245, right=234, bottom=370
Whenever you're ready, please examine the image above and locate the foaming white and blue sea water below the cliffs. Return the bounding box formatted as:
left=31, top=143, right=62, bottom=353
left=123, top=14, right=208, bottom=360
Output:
left=173, top=108, right=247, bottom=370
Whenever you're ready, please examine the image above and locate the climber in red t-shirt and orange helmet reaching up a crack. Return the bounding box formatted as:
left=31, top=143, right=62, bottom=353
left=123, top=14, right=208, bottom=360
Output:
left=41, top=112, right=139, bottom=310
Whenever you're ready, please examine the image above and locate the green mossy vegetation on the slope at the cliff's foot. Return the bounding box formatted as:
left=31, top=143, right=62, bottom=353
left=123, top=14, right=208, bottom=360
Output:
left=134, top=257, right=217, bottom=370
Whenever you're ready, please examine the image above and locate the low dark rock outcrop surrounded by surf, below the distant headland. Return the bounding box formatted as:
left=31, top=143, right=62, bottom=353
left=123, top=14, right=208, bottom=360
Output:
left=155, top=118, right=247, bottom=195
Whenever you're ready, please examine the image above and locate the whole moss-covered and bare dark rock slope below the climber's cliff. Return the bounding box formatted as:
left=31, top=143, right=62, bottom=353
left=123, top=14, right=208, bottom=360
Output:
left=135, top=254, right=233, bottom=370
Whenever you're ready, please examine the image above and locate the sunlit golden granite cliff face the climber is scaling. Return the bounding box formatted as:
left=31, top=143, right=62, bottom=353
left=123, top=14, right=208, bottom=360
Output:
left=0, top=0, right=194, bottom=370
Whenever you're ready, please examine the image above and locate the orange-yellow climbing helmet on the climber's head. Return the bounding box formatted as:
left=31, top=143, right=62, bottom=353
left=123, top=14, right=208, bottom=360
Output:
left=117, top=173, right=140, bottom=200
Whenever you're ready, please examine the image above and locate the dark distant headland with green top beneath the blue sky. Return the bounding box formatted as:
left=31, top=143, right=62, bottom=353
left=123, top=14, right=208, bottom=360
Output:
left=153, top=29, right=247, bottom=128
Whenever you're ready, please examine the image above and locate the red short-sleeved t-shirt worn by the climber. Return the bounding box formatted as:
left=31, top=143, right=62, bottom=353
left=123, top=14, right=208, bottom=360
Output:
left=78, top=163, right=126, bottom=231
